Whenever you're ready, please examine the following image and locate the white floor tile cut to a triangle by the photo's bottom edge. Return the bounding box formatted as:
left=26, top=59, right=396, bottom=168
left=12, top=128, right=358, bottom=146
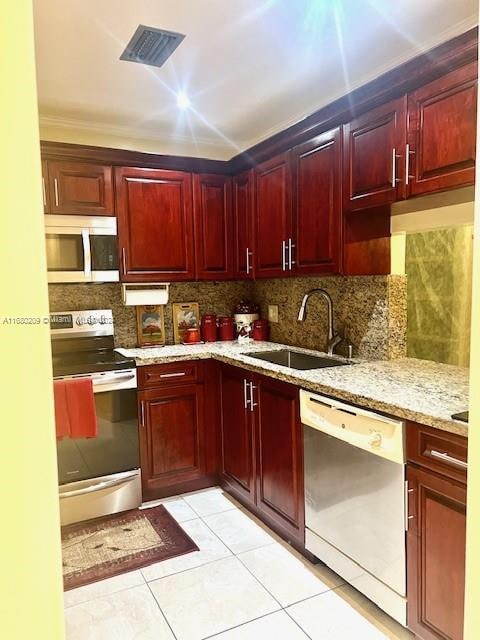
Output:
left=212, top=611, right=308, bottom=640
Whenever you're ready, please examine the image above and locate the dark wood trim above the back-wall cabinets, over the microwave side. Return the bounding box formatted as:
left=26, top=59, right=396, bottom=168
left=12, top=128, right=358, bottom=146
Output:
left=40, top=140, right=230, bottom=175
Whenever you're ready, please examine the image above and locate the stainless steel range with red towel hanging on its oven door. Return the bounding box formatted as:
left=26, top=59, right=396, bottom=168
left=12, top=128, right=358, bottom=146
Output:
left=51, top=310, right=142, bottom=525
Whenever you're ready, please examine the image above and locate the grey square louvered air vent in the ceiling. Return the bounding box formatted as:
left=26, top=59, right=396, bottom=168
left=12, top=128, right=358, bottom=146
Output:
left=120, top=24, right=185, bottom=67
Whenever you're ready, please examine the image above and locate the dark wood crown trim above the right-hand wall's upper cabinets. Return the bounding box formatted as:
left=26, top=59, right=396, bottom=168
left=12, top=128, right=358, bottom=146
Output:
left=230, top=27, right=478, bottom=174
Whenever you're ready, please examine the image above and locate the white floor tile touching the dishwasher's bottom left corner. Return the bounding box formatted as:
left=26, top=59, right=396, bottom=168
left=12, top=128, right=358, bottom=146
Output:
left=238, top=543, right=341, bottom=607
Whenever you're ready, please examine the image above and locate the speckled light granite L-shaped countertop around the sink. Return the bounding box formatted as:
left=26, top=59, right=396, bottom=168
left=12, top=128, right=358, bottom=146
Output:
left=116, top=342, right=469, bottom=436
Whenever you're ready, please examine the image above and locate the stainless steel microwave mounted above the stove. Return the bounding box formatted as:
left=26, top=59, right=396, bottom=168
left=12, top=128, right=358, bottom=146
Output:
left=45, top=215, right=119, bottom=282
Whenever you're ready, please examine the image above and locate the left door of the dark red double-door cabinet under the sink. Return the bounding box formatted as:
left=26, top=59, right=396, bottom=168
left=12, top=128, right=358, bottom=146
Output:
left=221, top=366, right=255, bottom=503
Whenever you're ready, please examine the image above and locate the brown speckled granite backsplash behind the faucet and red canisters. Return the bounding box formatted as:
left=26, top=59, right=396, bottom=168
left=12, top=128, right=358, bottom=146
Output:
left=49, top=276, right=407, bottom=360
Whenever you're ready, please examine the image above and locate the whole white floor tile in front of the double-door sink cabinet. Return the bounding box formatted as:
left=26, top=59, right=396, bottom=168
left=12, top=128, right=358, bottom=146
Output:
left=203, top=509, right=275, bottom=553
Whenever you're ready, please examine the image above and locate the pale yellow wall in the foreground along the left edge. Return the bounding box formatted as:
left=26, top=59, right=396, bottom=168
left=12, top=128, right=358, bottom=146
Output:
left=0, top=0, right=64, bottom=640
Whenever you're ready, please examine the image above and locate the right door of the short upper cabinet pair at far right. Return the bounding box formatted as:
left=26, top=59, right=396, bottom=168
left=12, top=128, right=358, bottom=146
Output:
left=408, top=62, right=477, bottom=196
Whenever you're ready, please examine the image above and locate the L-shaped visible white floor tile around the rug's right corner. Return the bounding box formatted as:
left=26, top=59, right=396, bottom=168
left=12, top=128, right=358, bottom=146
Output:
left=141, top=518, right=232, bottom=582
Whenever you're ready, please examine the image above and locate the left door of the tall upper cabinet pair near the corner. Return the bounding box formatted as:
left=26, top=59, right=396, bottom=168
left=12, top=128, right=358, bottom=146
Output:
left=254, top=154, right=292, bottom=278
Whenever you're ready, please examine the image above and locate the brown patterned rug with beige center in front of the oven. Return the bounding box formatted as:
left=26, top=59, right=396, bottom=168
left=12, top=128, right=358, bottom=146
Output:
left=62, top=505, right=198, bottom=591
